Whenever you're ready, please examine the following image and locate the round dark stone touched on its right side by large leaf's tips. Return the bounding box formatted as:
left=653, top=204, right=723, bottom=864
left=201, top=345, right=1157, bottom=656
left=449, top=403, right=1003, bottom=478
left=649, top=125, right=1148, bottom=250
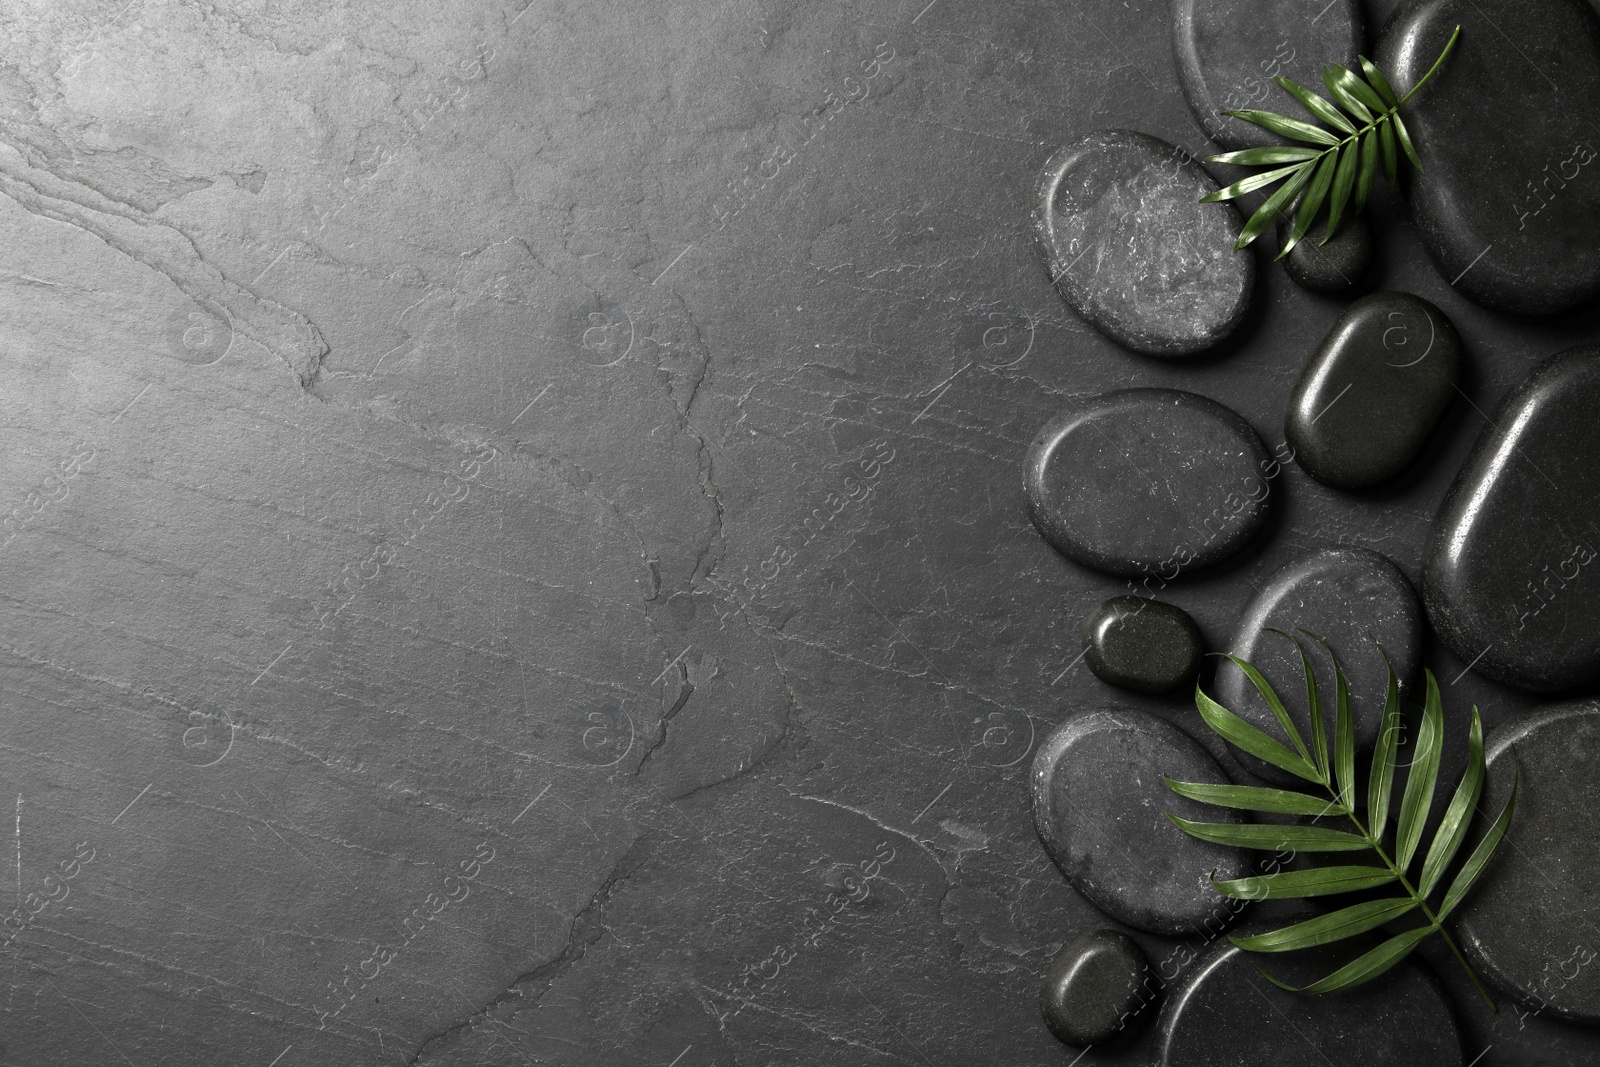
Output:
left=1032, top=710, right=1248, bottom=936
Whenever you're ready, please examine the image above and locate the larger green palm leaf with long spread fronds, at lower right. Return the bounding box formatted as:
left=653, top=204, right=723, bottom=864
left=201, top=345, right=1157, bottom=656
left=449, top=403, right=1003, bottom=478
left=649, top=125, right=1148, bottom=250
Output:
left=1163, top=630, right=1517, bottom=1009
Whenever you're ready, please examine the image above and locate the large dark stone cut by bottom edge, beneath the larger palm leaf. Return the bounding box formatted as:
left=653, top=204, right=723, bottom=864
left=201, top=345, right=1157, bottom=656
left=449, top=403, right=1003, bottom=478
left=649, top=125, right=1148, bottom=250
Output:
left=1154, top=923, right=1466, bottom=1067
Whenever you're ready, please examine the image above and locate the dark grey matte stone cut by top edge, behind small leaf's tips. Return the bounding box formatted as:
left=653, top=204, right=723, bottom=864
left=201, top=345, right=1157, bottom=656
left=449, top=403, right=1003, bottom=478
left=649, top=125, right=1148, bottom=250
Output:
left=1173, top=0, right=1365, bottom=149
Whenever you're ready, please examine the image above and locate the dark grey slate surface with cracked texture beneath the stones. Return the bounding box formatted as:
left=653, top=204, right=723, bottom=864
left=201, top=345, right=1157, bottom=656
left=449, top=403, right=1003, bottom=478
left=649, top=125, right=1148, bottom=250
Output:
left=0, top=0, right=1600, bottom=1067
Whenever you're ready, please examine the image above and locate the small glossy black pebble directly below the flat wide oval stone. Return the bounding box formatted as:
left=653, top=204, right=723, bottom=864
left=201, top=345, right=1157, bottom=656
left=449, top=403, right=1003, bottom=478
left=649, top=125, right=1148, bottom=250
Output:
left=1083, top=597, right=1205, bottom=693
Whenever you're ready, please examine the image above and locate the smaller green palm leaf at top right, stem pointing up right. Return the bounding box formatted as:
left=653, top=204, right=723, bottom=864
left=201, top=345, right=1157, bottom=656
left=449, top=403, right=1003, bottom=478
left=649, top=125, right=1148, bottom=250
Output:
left=1202, top=26, right=1461, bottom=252
